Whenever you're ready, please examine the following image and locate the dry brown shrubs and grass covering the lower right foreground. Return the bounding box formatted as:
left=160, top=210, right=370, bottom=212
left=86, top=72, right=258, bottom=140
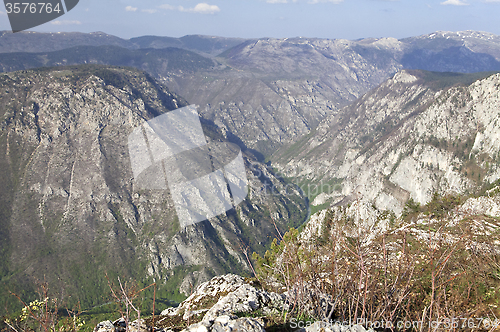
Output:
left=253, top=195, right=500, bottom=331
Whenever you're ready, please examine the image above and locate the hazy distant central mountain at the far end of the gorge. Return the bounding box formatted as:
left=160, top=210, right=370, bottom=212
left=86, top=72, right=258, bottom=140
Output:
left=165, top=38, right=399, bottom=155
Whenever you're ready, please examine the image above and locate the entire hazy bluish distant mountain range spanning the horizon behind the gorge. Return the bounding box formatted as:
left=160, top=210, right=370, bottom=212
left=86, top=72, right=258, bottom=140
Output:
left=0, top=31, right=500, bottom=159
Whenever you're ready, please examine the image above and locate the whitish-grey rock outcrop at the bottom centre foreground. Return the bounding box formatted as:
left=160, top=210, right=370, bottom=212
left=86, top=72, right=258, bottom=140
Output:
left=94, top=274, right=372, bottom=332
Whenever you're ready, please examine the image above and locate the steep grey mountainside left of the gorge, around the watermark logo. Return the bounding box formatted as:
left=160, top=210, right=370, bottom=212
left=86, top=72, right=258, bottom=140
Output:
left=0, top=66, right=307, bottom=305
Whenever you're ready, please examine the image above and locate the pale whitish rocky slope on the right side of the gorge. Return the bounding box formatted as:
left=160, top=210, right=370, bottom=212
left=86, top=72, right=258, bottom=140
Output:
left=273, top=71, right=500, bottom=213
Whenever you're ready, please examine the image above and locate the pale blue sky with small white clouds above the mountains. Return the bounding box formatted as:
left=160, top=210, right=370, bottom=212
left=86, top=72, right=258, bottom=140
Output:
left=0, top=0, right=500, bottom=40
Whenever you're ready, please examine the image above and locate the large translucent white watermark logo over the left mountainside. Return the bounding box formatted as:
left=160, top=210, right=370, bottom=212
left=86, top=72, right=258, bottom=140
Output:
left=128, top=106, right=248, bottom=227
